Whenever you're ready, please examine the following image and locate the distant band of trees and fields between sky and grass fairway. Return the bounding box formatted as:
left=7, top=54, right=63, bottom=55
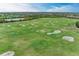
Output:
left=0, top=12, right=79, bottom=23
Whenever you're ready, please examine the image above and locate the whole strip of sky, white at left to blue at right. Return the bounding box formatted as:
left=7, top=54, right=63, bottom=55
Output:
left=0, top=3, right=79, bottom=12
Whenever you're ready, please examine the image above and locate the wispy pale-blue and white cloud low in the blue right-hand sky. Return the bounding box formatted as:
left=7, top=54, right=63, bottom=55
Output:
left=47, top=5, right=75, bottom=12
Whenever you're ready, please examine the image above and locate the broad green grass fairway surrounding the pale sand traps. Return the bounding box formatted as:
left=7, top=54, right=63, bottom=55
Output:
left=0, top=18, right=79, bottom=56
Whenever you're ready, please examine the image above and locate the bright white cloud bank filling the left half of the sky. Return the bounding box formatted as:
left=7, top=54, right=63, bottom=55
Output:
left=0, top=3, right=40, bottom=12
